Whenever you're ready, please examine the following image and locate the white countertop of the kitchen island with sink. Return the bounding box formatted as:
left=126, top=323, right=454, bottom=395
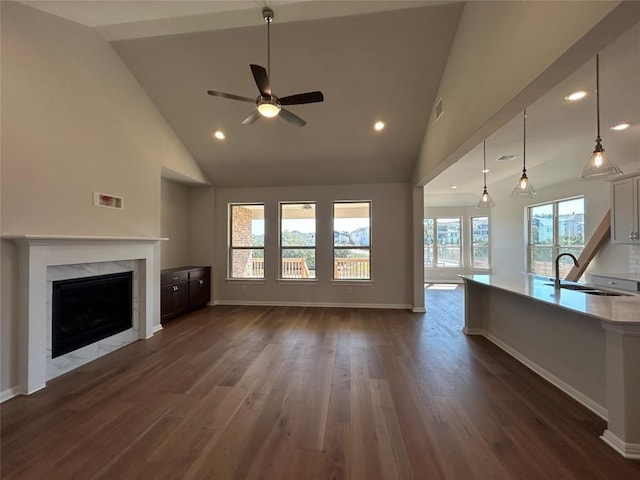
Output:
left=460, top=275, right=640, bottom=325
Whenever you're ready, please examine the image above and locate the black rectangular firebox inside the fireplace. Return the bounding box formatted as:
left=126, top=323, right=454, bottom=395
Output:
left=51, top=272, right=133, bottom=358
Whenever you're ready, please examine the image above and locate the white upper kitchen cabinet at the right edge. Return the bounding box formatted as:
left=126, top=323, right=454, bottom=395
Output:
left=611, top=174, right=640, bottom=244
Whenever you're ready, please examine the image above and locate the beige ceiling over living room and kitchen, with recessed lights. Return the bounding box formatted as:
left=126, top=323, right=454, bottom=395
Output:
left=17, top=0, right=640, bottom=205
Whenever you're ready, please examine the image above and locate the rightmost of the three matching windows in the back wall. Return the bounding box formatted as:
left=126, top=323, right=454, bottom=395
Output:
left=333, top=202, right=371, bottom=280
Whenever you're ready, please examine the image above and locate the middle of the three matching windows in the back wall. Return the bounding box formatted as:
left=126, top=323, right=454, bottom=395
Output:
left=280, top=202, right=316, bottom=278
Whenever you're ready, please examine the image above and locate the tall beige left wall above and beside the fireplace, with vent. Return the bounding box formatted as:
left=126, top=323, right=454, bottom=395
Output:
left=0, top=1, right=207, bottom=392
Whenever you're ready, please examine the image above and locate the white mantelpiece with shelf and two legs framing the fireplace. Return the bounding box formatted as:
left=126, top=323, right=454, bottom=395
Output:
left=8, top=235, right=164, bottom=395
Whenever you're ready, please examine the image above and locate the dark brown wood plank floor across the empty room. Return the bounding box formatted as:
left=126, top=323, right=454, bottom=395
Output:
left=0, top=287, right=640, bottom=480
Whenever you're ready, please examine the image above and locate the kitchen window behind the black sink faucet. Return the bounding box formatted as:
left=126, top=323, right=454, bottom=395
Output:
left=527, top=197, right=584, bottom=277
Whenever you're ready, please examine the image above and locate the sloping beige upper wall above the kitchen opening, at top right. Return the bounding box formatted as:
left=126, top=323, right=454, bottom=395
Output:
left=413, top=1, right=640, bottom=185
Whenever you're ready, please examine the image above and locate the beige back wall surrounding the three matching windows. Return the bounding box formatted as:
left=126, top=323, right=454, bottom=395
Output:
left=213, top=183, right=414, bottom=308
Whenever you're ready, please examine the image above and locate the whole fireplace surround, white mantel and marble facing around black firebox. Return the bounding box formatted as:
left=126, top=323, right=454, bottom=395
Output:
left=2, top=235, right=163, bottom=394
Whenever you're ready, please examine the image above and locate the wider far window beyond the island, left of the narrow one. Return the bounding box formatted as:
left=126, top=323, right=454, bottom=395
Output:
left=424, top=217, right=462, bottom=268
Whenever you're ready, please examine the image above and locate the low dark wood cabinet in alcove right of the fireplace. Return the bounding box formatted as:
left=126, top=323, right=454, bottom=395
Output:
left=160, top=266, right=211, bottom=323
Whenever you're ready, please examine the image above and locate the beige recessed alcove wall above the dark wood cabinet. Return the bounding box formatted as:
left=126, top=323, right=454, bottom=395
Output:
left=160, top=178, right=191, bottom=268
